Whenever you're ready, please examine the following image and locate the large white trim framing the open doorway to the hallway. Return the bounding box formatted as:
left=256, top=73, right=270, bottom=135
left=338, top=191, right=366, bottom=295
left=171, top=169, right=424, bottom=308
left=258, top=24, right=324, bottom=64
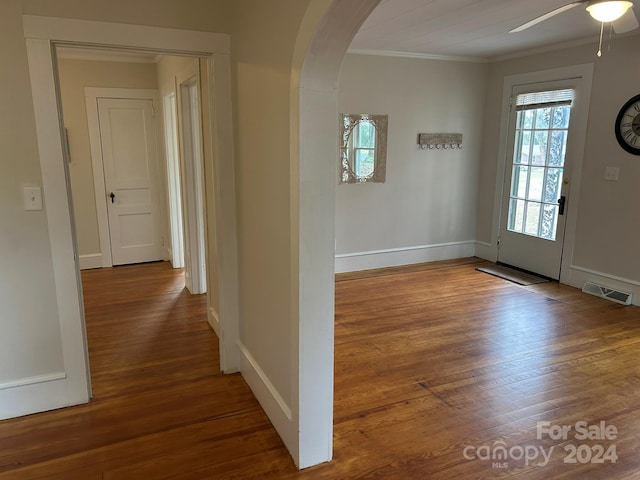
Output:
left=23, top=15, right=240, bottom=409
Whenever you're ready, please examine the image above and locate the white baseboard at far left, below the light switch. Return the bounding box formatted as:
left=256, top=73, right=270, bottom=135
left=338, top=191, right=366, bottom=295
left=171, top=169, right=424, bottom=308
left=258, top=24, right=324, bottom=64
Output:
left=0, top=372, right=69, bottom=420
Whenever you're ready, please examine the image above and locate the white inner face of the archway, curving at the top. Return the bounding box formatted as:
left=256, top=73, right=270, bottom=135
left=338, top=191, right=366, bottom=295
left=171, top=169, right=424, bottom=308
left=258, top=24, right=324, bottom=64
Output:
left=291, top=0, right=380, bottom=468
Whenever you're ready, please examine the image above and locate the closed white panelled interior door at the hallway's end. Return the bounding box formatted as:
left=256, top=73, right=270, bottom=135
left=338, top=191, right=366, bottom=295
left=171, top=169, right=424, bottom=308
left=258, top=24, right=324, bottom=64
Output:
left=98, top=98, right=162, bottom=265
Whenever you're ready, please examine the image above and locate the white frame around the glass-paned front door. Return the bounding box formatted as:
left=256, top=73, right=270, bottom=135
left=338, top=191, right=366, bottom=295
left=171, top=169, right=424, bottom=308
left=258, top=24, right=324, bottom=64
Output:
left=491, top=63, right=594, bottom=283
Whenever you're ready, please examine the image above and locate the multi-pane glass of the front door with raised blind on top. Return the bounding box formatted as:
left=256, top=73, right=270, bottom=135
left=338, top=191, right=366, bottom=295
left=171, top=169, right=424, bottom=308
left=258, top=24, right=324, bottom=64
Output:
left=507, top=90, right=573, bottom=240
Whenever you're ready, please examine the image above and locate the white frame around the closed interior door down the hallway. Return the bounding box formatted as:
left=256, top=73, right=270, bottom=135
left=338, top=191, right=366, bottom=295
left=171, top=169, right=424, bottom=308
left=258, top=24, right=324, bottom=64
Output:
left=84, top=87, right=167, bottom=267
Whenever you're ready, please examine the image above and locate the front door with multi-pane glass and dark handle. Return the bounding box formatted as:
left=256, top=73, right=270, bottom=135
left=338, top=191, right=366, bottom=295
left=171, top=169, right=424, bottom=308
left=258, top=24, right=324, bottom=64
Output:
left=498, top=86, right=574, bottom=279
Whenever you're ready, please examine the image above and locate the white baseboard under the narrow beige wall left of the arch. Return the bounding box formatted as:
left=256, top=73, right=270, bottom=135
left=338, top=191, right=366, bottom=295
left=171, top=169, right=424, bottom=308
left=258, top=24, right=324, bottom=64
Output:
left=238, top=343, right=298, bottom=458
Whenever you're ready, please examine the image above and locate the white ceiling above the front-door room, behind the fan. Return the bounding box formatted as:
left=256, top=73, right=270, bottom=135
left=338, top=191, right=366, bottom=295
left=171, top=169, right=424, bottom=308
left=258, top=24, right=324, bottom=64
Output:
left=349, top=0, right=640, bottom=60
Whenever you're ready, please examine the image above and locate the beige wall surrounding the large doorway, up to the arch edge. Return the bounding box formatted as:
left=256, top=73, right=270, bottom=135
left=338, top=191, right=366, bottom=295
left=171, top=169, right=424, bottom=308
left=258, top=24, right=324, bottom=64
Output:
left=0, top=0, right=326, bottom=462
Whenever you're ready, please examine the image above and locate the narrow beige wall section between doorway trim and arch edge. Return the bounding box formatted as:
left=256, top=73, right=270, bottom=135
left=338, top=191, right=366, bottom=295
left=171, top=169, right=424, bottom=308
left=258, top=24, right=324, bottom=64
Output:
left=231, top=0, right=309, bottom=406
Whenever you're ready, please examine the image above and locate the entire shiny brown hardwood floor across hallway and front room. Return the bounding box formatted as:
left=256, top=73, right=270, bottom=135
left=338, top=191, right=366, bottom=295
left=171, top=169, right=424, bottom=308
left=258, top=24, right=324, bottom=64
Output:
left=0, top=259, right=640, bottom=480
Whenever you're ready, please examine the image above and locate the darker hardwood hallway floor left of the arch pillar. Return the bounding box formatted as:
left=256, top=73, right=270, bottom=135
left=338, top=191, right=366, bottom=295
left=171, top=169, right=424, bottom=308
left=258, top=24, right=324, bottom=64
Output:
left=0, top=262, right=293, bottom=480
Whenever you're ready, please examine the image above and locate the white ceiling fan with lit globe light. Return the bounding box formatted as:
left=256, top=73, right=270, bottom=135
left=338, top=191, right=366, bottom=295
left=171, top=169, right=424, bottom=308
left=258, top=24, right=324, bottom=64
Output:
left=509, top=0, right=639, bottom=33
